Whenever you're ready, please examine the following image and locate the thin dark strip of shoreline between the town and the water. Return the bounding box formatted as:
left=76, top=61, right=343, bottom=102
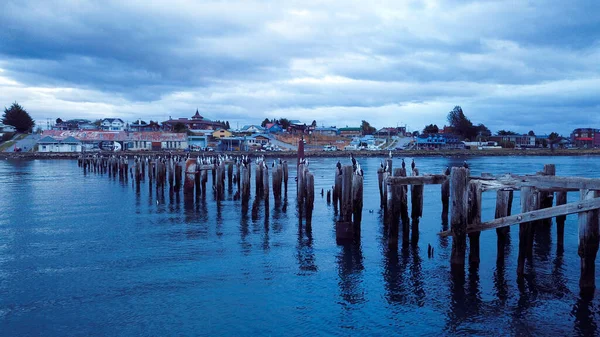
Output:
left=0, top=149, right=600, bottom=160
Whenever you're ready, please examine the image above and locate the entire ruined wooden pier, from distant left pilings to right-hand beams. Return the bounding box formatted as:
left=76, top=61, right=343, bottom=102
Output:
left=78, top=155, right=600, bottom=290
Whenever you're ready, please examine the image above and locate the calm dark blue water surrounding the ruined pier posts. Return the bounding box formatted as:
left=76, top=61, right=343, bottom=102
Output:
left=0, top=157, right=600, bottom=336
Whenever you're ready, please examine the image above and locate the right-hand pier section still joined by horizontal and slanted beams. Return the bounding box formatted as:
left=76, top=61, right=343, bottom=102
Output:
left=382, top=164, right=600, bottom=290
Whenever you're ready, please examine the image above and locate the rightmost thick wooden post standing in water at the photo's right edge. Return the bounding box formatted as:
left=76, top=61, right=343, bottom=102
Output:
left=577, top=190, right=600, bottom=291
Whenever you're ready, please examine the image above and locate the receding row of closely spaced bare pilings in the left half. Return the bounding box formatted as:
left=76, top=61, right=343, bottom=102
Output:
left=77, top=154, right=304, bottom=213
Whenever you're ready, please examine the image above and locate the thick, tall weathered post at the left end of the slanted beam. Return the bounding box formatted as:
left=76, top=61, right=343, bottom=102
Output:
left=450, top=167, right=469, bottom=266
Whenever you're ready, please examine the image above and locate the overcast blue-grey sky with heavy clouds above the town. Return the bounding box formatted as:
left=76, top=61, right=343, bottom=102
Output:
left=0, top=0, right=600, bottom=134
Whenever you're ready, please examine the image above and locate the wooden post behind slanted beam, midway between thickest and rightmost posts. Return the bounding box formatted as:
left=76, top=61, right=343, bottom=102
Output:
left=517, top=186, right=540, bottom=276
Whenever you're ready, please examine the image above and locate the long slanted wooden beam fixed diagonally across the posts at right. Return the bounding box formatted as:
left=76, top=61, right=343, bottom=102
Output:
left=438, top=198, right=600, bottom=237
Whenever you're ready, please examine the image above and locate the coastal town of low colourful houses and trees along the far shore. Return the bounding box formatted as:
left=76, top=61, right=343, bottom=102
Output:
left=0, top=103, right=600, bottom=153
